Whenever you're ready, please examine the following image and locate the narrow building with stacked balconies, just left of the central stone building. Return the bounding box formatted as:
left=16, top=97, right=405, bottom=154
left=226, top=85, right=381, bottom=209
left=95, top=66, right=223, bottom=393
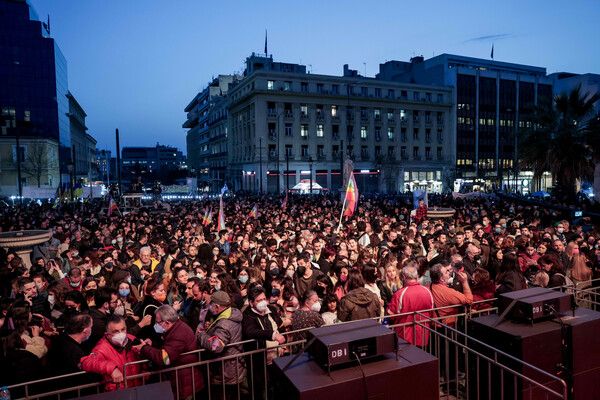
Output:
left=183, top=75, right=239, bottom=191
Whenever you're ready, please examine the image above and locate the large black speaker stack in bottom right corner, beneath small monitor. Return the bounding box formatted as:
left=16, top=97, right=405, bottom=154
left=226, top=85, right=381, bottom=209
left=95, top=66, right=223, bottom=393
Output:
left=468, top=308, right=600, bottom=400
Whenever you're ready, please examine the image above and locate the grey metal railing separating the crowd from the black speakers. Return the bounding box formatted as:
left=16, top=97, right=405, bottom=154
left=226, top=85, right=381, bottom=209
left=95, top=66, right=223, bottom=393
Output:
left=9, top=288, right=600, bottom=399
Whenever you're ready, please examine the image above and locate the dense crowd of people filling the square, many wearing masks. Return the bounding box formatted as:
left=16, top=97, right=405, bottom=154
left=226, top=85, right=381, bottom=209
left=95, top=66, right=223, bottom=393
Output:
left=0, top=195, right=600, bottom=398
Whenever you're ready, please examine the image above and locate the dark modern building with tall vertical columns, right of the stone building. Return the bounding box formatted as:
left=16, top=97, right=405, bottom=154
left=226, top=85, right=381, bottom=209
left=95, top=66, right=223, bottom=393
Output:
left=377, top=54, right=552, bottom=189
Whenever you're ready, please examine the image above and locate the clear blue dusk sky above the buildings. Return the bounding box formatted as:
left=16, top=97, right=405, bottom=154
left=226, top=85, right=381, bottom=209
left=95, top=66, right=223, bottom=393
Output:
left=31, top=0, right=600, bottom=155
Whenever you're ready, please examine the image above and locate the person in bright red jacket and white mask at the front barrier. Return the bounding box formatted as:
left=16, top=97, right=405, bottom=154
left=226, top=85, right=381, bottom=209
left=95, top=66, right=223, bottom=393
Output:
left=81, top=315, right=143, bottom=391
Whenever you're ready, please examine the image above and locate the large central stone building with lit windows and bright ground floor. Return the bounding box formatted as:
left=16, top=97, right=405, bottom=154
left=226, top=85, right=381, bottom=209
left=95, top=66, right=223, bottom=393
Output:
left=227, top=54, right=456, bottom=192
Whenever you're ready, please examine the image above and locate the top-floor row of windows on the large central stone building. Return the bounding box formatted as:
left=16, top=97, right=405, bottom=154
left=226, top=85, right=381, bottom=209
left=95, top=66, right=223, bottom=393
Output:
left=267, top=80, right=444, bottom=103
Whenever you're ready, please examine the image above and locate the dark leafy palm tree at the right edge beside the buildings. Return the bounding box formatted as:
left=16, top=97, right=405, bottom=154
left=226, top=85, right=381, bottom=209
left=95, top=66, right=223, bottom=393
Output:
left=519, top=86, right=600, bottom=197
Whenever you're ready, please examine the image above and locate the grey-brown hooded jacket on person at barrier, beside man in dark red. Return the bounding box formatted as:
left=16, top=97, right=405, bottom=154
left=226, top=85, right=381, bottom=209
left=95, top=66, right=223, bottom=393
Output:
left=196, top=307, right=246, bottom=385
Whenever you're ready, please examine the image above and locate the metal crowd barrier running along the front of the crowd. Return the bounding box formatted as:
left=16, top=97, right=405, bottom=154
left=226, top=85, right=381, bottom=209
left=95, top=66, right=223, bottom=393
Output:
left=9, top=289, right=584, bottom=400
